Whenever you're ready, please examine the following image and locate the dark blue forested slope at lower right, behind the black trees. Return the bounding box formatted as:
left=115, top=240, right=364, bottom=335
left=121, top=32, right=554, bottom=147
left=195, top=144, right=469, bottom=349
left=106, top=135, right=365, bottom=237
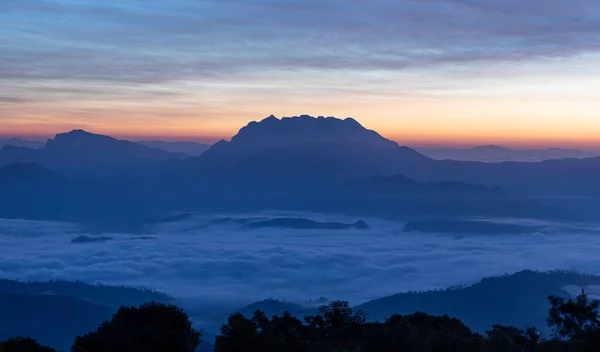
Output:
left=356, top=270, right=600, bottom=332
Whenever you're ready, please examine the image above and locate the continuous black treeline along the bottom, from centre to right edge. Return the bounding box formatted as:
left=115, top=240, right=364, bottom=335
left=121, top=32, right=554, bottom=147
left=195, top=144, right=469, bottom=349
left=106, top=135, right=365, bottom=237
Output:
left=214, top=294, right=600, bottom=352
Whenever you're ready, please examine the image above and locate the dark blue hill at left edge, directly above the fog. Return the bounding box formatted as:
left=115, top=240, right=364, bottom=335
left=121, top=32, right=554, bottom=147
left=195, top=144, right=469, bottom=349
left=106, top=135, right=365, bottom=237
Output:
left=0, top=163, right=160, bottom=231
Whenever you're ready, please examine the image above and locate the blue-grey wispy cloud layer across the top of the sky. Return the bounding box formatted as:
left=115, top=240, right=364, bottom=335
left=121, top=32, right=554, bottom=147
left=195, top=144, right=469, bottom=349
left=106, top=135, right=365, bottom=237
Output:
left=0, top=0, right=600, bottom=82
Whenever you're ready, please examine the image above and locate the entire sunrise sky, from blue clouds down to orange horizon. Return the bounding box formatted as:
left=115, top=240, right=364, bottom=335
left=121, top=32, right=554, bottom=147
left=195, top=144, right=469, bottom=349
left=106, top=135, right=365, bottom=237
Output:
left=0, top=0, right=600, bottom=149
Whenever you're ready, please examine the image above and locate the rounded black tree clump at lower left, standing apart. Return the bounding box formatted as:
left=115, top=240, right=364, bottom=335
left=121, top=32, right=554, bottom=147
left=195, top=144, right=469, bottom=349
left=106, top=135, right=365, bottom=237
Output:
left=71, top=302, right=200, bottom=352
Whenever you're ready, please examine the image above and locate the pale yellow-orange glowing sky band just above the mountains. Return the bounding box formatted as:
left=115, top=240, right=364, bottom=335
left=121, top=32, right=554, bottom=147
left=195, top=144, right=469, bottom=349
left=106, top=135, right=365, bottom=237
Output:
left=0, top=52, right=600, bottom=150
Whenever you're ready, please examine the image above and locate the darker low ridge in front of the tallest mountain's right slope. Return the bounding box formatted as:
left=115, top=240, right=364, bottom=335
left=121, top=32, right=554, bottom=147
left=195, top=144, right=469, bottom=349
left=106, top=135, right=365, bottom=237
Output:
left=332, top=174, right=573, bottom=221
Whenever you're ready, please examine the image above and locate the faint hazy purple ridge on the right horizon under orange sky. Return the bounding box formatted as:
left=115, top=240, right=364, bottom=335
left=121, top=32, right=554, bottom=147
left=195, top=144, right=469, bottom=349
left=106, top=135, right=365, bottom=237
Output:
left=414, top=145, right=600, bottom=162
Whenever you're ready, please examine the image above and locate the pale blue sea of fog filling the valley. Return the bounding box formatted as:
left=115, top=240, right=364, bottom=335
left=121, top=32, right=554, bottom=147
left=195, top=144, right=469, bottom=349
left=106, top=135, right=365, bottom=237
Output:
left=0, top=214, right=600, bottom=307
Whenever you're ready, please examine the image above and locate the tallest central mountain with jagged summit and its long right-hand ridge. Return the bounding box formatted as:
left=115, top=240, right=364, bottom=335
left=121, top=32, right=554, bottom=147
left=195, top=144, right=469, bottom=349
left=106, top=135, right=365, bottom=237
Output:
left=190, top=115, right=600, bottom=202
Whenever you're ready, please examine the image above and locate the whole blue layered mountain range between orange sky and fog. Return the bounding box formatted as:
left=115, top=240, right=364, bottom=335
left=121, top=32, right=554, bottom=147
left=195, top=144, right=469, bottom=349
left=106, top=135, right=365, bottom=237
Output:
left=0, top=115, right=600, bottom=228
